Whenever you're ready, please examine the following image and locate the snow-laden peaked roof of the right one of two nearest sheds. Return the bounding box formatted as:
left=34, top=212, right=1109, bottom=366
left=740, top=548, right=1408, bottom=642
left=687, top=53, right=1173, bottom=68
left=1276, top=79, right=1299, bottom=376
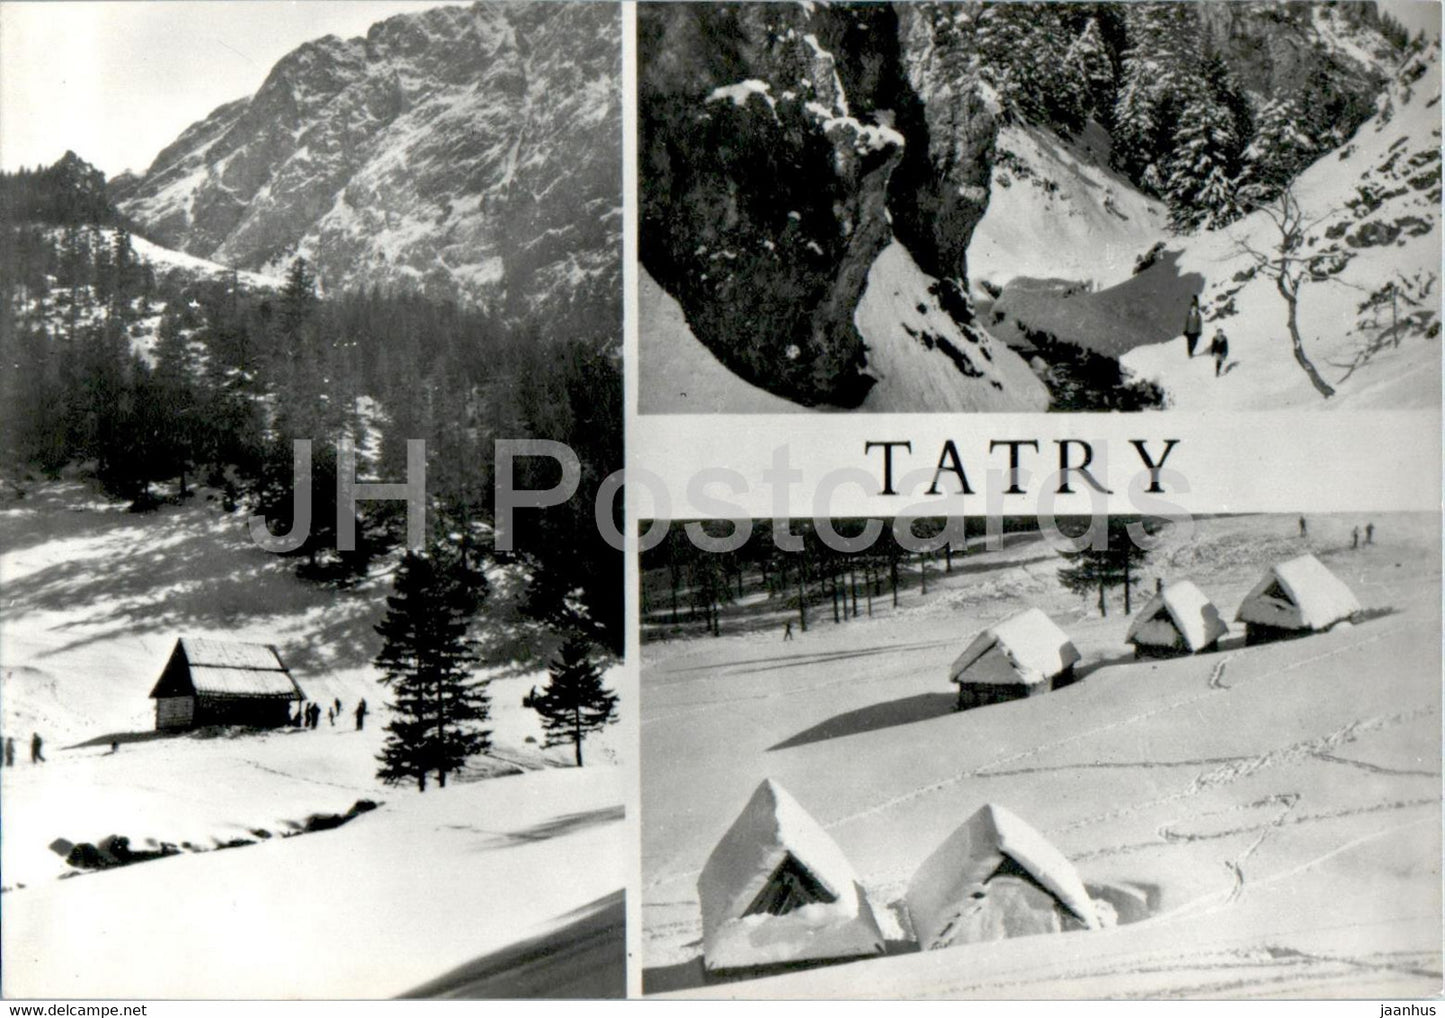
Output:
left=905, top=803, right=1098, bottom=950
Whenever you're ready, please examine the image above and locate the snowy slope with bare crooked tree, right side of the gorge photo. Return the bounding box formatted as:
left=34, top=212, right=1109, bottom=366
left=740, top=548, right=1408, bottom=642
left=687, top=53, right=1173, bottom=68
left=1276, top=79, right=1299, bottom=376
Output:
left=1123, top=43, right=1441, bottom=409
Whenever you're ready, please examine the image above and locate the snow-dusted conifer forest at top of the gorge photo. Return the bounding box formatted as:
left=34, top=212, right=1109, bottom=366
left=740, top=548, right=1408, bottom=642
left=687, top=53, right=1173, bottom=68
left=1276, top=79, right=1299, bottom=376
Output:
left=953, top=3, right=1423, bottom=231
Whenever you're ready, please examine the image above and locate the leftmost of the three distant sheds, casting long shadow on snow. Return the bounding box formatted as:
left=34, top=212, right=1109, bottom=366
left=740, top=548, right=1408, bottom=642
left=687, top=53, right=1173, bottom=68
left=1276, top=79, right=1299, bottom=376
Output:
left=948, top=607, right=1079, bottom=710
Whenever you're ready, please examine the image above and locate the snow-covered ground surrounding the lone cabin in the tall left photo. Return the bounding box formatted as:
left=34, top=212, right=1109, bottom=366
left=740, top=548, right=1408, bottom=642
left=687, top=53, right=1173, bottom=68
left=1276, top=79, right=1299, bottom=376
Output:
left=0, top=483, right=634, bottom=998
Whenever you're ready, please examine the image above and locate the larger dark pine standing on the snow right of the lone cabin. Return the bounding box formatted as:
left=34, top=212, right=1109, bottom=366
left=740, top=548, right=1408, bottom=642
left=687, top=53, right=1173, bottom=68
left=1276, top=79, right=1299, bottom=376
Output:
left=376, top=551, right=491, bottom=791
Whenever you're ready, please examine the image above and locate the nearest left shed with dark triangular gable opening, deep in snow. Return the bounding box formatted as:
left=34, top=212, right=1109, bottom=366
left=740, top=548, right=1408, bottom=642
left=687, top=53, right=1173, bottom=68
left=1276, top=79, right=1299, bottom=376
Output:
left=698, top=779, right=883, bottom=972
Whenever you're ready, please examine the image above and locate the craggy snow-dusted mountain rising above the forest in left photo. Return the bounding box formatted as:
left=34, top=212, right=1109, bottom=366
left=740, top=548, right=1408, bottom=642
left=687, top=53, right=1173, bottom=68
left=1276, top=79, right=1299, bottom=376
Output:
left=113, top=3, right=621, bottom=327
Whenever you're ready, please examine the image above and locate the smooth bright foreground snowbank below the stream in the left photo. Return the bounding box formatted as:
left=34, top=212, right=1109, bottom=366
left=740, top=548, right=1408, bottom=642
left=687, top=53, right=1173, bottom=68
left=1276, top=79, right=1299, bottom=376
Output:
left=0, top=769, right=629, bottom=999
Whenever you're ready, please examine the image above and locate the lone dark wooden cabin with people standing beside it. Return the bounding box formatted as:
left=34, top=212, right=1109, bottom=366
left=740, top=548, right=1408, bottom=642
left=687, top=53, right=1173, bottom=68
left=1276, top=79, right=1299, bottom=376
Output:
left=150, top=636, right=306, bottom=730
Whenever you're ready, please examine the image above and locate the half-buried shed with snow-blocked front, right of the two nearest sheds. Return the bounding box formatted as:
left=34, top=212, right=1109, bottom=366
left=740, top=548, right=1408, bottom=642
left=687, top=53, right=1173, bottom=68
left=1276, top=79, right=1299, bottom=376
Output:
left=903, top=803, right=1100, bottom=950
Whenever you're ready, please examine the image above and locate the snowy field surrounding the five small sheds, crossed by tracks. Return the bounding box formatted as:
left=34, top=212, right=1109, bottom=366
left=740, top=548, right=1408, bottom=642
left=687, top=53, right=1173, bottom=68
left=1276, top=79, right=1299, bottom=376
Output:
left=642, top=515, right=1441, bottom=999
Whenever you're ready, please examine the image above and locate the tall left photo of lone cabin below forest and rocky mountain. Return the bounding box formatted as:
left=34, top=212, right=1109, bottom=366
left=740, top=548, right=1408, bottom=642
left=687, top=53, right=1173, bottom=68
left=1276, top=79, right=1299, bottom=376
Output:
left=0, top=0, right=636, bottom=1014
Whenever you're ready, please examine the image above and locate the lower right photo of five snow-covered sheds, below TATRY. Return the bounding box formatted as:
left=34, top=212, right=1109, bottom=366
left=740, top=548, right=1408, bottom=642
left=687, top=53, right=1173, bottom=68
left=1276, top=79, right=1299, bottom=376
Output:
left=640, top=512, right=1441, bottom=1006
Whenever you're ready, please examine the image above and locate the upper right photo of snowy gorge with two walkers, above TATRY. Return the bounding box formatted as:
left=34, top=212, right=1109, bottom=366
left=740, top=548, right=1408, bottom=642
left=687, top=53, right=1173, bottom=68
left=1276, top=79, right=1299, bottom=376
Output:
left=637, top=0, right=1441, bottom=415
